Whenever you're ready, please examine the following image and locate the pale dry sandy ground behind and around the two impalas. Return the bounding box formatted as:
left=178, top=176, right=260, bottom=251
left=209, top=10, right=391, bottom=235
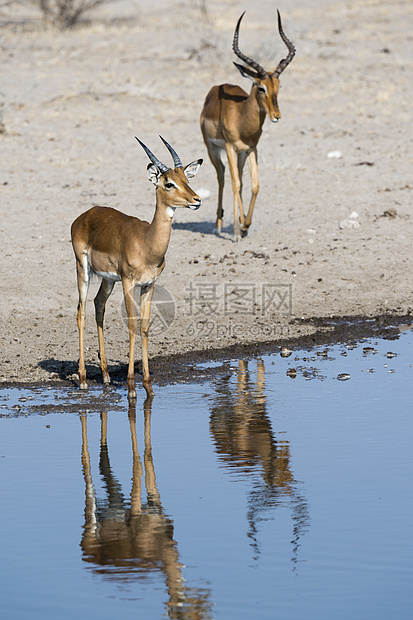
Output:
left=0, top=0, right=413, bottom=383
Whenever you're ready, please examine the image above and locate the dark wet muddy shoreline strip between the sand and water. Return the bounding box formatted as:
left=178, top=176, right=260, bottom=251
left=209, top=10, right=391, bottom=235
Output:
left=0, top=314, right=413, bottom=398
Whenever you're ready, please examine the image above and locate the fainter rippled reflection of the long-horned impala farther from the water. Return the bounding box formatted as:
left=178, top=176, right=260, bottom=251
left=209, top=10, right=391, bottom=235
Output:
left=210, top=359, right=309, bottom=563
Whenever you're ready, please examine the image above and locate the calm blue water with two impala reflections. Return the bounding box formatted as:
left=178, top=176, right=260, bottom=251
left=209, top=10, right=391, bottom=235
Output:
left=0, top=331, right=413, bottom=620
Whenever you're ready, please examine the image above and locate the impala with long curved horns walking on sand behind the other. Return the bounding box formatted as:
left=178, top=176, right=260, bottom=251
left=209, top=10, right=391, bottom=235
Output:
left=201, top=11, right=295, bottom=240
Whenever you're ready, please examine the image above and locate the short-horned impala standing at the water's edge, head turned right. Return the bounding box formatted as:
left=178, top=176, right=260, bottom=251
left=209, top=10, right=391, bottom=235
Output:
left=71, top=136, right=202, bottom=399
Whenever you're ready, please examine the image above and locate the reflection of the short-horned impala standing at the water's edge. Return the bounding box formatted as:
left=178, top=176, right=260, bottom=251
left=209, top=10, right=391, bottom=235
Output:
left=81, top=398, right=212, bottom=619
